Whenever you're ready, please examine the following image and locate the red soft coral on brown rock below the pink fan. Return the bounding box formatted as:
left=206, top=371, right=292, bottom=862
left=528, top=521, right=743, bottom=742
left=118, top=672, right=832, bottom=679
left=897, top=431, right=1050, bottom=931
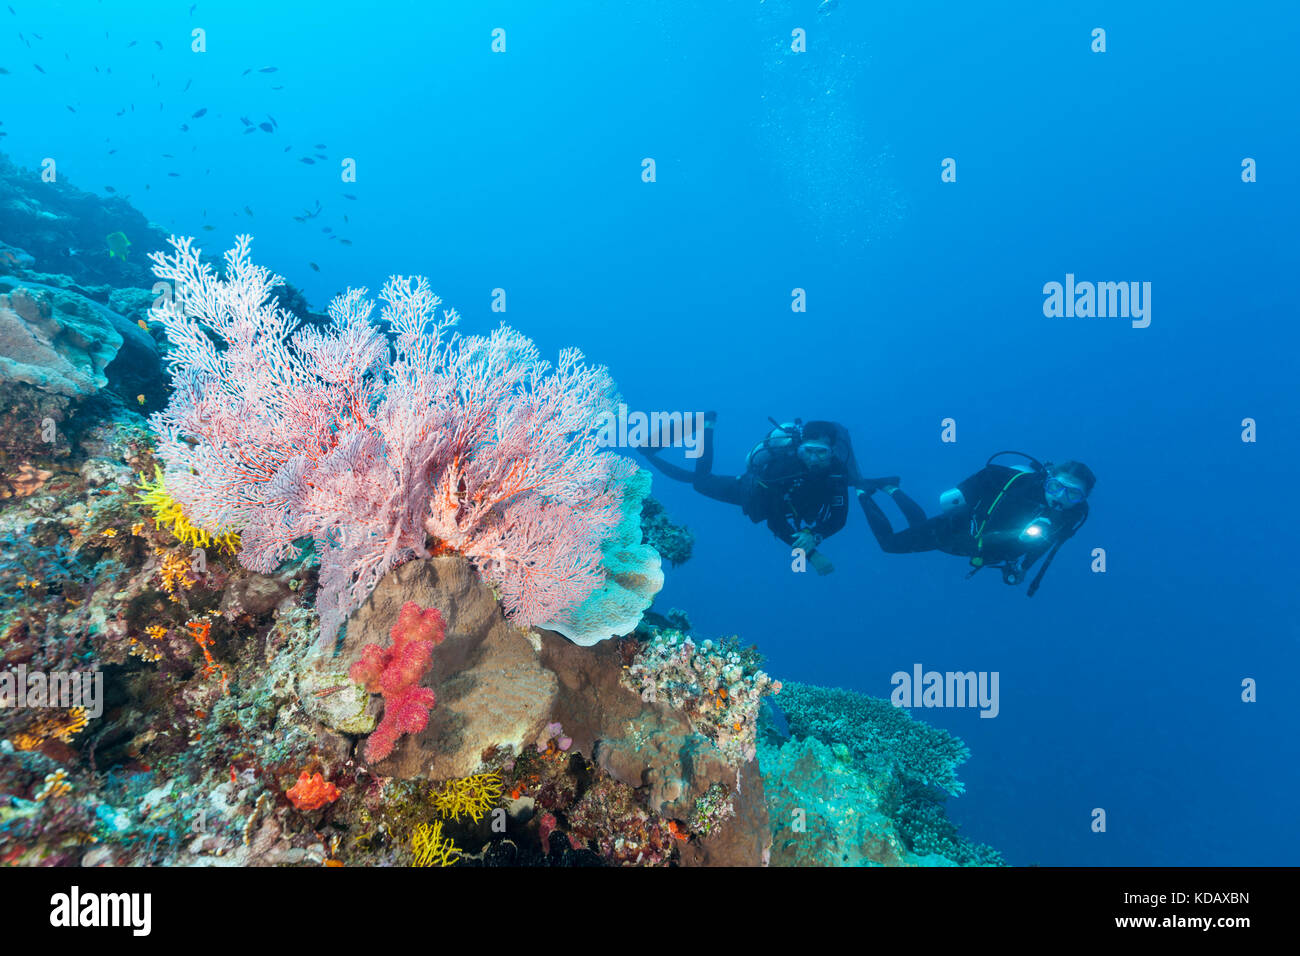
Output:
left=348, top=601, right=447, bottom=762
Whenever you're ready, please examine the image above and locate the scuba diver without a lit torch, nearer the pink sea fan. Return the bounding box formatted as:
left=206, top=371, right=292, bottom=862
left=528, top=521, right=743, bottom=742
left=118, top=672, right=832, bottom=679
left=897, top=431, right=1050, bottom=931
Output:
left=641, top=412, right=898, bottom=575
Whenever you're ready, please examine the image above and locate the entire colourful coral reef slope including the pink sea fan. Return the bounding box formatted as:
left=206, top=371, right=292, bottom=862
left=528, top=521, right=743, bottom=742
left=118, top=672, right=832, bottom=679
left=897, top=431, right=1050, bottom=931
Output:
left=0, top=151, right=998, bottom=866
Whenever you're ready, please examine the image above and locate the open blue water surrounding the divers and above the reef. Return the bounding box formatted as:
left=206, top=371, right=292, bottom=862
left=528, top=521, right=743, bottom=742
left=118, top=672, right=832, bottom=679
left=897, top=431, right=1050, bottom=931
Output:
left=0, top=0, right=1300, bottom=865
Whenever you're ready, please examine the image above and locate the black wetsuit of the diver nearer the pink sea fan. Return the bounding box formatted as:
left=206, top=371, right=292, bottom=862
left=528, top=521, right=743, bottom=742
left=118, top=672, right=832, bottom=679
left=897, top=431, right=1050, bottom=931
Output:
left=642, top=428, right=849, bottom=554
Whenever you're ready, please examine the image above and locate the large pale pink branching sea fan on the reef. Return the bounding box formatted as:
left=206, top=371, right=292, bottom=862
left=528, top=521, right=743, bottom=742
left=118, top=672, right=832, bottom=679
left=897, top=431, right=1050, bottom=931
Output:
left=151, top=237, right=636, bottom=641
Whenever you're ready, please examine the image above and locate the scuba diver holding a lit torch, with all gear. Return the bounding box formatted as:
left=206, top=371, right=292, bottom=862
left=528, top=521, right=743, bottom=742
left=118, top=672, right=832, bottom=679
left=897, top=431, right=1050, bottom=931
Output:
left=858, top=451, right=1097, bottom=597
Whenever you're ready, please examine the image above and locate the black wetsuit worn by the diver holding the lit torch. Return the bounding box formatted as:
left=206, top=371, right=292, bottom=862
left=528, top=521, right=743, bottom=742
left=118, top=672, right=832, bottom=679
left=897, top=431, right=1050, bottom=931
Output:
left=859, top=464, right=1088, bottom=572
